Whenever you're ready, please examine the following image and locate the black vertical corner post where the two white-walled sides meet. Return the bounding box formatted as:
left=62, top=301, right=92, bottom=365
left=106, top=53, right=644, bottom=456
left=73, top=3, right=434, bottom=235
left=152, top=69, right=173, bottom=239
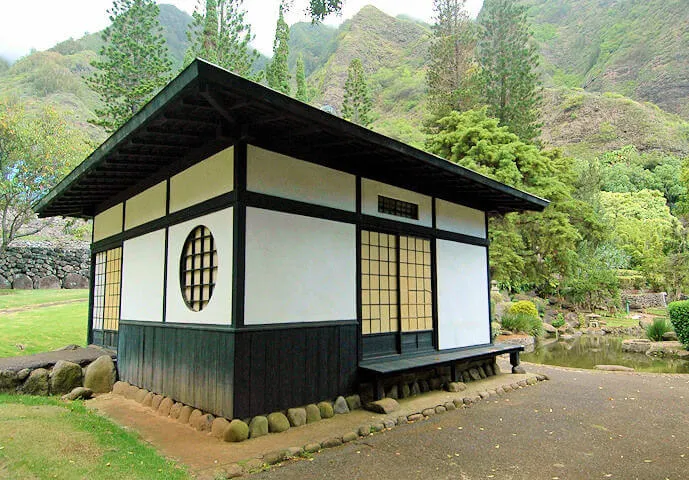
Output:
left=231, top=141, right=247, bottom=328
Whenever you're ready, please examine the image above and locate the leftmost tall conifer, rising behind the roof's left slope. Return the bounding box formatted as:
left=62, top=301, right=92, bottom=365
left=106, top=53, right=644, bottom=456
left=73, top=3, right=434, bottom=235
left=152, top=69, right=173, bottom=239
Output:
left=87, top=0, right=172, bottom=132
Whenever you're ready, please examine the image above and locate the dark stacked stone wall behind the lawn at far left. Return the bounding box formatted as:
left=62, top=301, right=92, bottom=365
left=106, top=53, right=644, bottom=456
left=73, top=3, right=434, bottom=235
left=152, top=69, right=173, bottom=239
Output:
left=0, top=247, right=91, bottom=289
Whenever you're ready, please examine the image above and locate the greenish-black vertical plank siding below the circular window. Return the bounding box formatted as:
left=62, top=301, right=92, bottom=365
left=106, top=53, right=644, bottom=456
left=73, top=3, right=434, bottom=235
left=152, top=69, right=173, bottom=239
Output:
left=117, top=321, right=234, bottom=418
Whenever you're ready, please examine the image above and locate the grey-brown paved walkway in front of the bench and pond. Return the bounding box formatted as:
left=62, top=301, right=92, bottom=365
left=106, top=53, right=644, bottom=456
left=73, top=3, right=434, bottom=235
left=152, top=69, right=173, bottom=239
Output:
left=252, top=364, right=689, bottom=480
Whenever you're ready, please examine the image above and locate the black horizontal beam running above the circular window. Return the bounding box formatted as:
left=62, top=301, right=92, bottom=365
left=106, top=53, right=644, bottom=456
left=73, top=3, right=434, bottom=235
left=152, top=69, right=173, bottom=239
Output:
left=91, top=192, right=236, bottom=251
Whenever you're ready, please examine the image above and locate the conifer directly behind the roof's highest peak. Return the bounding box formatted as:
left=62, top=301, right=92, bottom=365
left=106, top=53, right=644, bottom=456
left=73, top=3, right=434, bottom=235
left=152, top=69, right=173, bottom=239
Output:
left=184, top=0, right=260, bottom=81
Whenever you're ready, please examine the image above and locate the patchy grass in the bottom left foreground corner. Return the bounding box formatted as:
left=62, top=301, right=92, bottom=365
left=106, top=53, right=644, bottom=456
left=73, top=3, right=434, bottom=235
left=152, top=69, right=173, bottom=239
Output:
left=0, top=395, right=189, bottom=480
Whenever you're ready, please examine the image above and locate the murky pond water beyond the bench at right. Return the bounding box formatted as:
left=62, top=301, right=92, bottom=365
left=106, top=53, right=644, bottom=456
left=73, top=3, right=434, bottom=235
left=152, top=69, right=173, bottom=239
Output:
left=521, top=335, right=689, bottom=373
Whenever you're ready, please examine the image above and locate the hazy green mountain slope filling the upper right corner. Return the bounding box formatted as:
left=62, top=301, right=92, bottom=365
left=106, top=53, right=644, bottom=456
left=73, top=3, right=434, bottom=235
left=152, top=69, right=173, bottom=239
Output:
left=524, top=0, right=689, bottom=119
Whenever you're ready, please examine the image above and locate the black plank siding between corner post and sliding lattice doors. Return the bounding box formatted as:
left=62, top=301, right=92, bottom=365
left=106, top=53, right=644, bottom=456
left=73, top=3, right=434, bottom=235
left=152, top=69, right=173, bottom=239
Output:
left=234, top=321, right=358, bottom=418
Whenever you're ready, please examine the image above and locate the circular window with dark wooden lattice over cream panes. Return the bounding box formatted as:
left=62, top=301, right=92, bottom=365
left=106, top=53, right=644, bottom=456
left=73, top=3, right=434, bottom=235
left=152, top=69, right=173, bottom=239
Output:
left=179, top=225, right=218, bottom=312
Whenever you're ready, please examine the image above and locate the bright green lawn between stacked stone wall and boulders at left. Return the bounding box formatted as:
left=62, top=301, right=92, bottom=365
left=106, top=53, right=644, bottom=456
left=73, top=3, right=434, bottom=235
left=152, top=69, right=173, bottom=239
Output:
left=0, top=290, right=88, bottom=358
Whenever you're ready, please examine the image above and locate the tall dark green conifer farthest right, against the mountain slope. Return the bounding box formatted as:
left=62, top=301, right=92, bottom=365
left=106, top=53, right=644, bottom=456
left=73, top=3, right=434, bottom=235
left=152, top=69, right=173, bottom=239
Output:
left=478, top=0, right=542, bottom=142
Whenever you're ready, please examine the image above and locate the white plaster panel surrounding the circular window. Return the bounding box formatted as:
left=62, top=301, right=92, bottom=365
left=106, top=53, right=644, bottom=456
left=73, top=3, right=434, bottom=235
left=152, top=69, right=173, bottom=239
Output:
left=165, top=208, right=233, bottom=325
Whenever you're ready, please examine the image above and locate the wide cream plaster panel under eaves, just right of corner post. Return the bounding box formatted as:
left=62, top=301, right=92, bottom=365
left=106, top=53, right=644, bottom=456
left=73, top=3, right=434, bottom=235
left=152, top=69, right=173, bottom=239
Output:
left=247, top=145, right=356, bottom=212
